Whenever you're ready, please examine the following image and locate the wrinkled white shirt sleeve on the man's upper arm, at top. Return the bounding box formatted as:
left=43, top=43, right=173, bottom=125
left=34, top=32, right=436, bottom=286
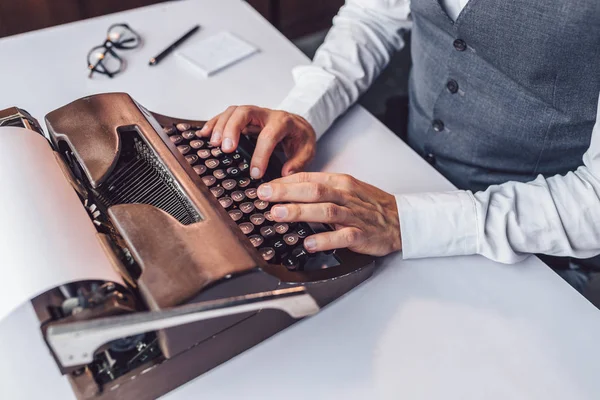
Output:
left=278, top=0, right=411, bottom=138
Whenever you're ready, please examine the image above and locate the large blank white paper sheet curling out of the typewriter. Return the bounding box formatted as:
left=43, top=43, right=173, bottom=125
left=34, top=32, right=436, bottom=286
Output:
left=0, top=127, right=123, bottom=321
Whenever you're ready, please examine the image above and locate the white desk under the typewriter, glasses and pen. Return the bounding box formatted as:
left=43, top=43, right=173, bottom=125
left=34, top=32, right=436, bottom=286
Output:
left=0, top=0, right=600, bottom=400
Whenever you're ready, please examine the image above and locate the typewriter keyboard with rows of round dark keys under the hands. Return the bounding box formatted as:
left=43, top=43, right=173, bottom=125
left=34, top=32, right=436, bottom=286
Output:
left=163, top=123, right=331, bottom=271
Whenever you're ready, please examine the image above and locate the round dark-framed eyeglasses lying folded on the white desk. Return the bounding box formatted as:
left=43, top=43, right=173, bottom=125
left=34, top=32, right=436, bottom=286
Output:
left=87, top=24, right=142, bottom=78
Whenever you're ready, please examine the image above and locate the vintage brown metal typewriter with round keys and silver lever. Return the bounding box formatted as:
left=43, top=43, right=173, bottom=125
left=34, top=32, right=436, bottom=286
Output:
left=0, top=93, right=374, bottom=399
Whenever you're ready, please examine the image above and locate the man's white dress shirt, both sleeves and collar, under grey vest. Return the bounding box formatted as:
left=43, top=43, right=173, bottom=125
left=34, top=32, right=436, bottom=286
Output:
left=279, top=0, right=600, bottom=263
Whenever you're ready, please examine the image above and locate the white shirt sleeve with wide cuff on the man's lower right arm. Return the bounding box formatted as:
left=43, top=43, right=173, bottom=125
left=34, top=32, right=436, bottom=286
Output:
left=396, top=93, right=600, bottom=263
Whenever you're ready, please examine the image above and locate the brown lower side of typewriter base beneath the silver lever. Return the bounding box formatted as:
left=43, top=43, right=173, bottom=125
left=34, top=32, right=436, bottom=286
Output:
left=69, top=262, right=374, bottom=400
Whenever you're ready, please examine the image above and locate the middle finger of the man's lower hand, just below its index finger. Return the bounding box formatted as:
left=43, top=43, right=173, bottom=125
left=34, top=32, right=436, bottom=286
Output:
left=271, top=203, right=352, bottom=225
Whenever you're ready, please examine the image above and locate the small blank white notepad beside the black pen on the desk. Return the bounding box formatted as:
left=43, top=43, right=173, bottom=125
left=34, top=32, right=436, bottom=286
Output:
left=177, top=32, right=258, bottom=77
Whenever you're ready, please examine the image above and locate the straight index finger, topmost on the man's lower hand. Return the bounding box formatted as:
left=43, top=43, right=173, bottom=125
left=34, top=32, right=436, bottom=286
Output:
left=257, top=181, right=344, bottom=204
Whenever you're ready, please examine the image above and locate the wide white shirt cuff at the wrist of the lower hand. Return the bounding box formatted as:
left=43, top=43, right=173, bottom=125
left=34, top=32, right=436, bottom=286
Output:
left=395, top=191, right=479, bottom=259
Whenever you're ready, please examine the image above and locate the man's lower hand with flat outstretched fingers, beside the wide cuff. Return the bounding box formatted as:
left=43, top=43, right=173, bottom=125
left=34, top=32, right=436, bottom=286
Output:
left=258, top=173, right=402, bottom=256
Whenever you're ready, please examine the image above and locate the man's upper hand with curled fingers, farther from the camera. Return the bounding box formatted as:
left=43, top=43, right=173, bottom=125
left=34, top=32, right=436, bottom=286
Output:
left=200, top=106, right=316, bottom=178
